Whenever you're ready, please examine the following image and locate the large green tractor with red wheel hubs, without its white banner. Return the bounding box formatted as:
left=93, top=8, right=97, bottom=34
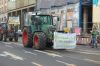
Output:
left=22, top=15, right=55, bottom=49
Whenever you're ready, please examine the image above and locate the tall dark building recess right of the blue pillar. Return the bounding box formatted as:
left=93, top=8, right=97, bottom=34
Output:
left=80, top=0, right=93, bottom=33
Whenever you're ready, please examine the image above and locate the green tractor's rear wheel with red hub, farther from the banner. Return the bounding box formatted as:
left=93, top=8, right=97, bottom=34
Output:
left=22, top=28, right=33, bottom=48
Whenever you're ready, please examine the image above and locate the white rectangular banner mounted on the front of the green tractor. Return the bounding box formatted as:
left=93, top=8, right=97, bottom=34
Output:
left=53, top=32, right=76, bottom=49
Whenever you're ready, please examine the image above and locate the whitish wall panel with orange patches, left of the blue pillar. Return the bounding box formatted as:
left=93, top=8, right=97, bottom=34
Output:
left=67, top=3, right=79, bottom=28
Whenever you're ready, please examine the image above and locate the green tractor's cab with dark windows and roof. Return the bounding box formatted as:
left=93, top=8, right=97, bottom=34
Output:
left=31, top=15, right=53, bottom=32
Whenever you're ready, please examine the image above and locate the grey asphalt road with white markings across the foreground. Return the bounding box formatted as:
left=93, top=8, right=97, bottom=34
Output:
left=0, top=42, right=100, bottom=66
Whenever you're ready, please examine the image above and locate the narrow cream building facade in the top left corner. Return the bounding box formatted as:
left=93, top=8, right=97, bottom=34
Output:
left=0, top=0, right=7, bottom=21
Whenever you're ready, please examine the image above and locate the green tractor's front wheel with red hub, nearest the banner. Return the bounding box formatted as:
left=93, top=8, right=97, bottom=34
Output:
left=33, top=32, right=46, bottom=50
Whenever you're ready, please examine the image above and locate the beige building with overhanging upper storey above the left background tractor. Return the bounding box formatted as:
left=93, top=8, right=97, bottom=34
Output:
left=8, top=0, right=36, bottom=29
